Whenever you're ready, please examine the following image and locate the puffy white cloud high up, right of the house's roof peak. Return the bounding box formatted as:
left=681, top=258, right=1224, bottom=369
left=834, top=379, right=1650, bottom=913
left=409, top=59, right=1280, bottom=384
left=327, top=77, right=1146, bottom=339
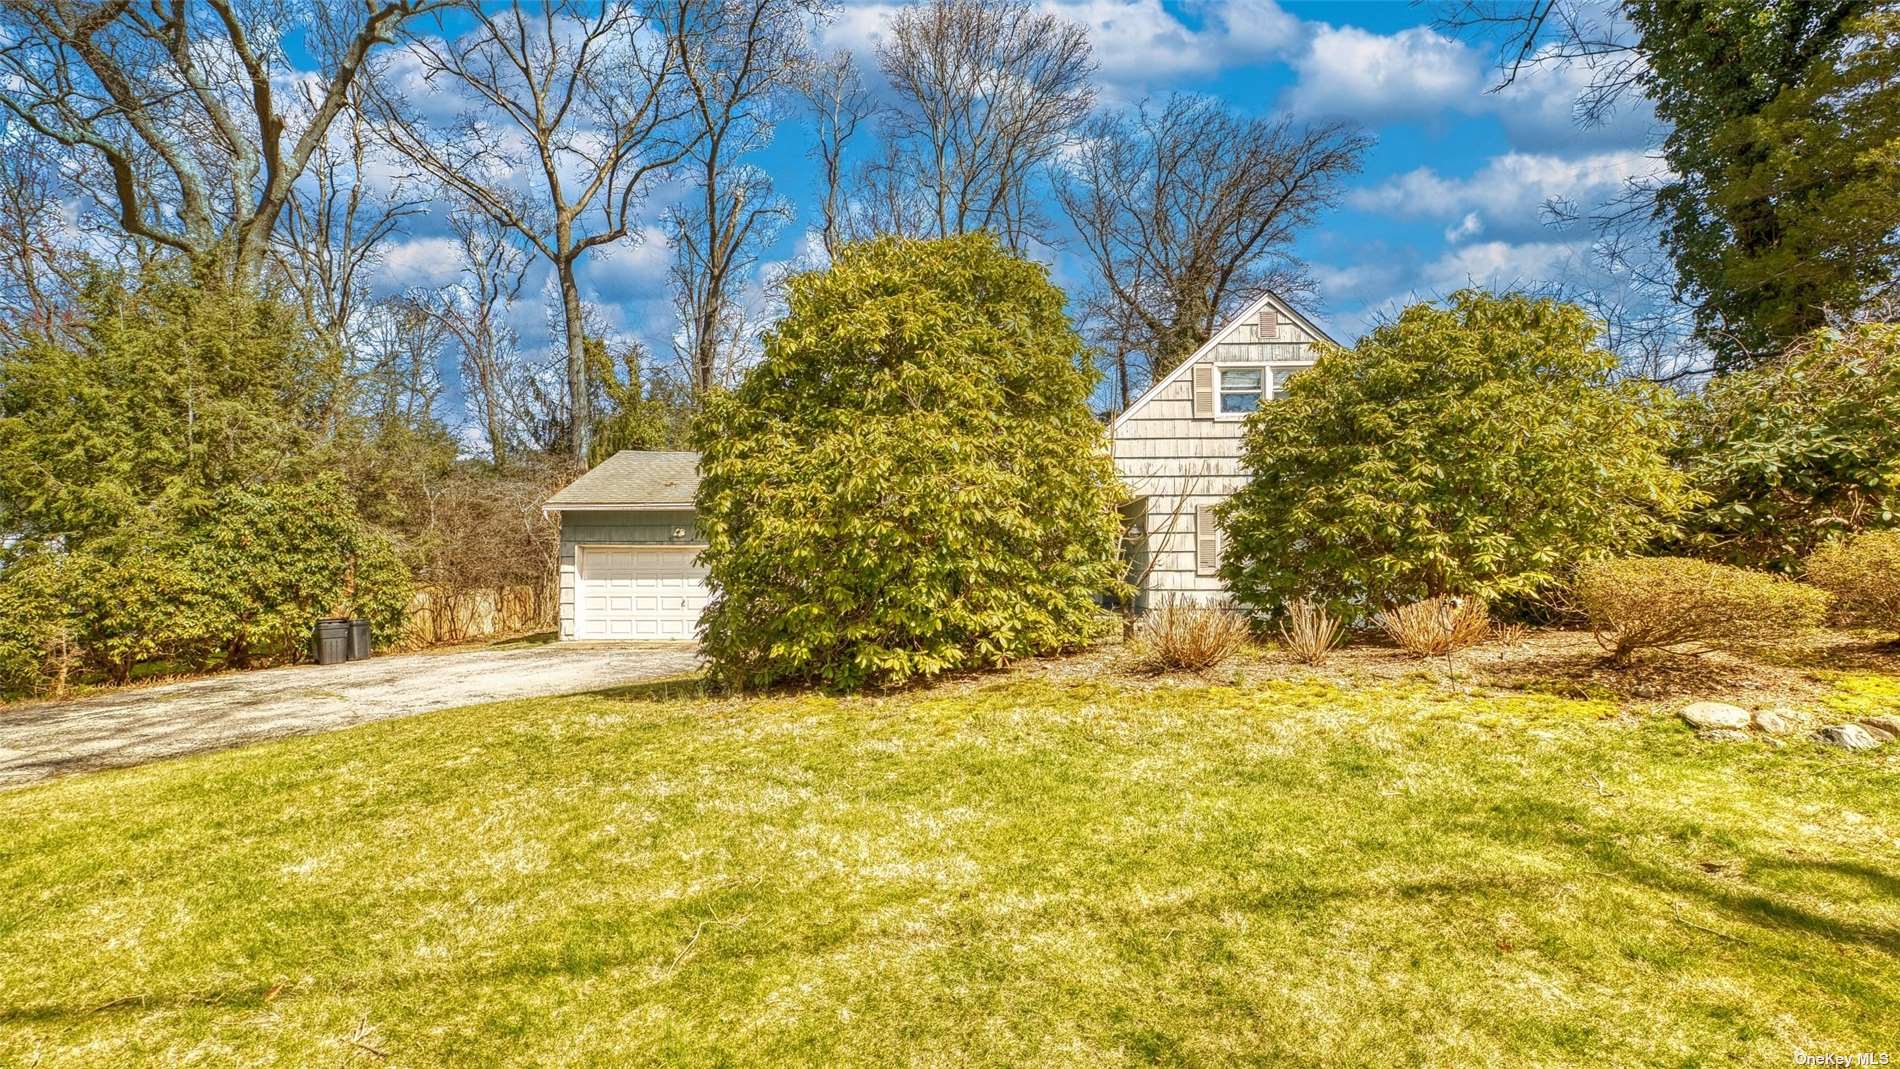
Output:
left=1286, top=27, right=1484, bottom=123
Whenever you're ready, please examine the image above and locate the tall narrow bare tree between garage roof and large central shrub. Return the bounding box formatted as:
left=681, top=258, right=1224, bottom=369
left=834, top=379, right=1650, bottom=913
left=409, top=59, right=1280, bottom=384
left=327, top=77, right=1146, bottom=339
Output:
left=665, top=0, right=813, bottom=393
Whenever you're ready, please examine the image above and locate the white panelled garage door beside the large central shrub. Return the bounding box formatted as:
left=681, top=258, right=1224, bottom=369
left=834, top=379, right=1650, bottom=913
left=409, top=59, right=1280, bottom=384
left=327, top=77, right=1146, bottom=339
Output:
left=574, top=545, right=707, bottom=638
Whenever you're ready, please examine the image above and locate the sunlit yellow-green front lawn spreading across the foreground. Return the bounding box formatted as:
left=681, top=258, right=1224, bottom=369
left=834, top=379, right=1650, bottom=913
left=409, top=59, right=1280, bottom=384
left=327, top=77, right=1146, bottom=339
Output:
left=0, top=678, right=1900, bottom=1067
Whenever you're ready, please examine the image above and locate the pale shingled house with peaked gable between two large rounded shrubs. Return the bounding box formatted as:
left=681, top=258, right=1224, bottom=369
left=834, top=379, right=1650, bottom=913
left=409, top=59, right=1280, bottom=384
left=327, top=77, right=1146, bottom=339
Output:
left=1108, top=292, right=1332, bottom=610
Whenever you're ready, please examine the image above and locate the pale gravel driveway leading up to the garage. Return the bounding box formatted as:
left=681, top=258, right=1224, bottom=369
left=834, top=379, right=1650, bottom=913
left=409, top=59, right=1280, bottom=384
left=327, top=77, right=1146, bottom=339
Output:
left=0, top=642, right=699, bottom=788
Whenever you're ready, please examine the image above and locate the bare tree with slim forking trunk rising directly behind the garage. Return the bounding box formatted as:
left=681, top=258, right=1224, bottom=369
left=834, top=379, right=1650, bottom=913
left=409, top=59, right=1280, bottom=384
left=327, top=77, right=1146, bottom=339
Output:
left=372, top=0, right=694, bottom=459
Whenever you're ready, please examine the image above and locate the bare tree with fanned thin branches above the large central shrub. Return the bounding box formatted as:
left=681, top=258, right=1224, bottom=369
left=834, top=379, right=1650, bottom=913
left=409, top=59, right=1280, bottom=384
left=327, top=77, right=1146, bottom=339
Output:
left=866, top=0, right=1094, bottom=251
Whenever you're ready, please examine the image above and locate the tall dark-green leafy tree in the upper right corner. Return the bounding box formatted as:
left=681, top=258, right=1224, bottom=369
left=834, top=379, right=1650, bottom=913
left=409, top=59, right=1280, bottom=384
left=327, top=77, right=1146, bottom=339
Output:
left=1625, top=0, right=1900, bottom=368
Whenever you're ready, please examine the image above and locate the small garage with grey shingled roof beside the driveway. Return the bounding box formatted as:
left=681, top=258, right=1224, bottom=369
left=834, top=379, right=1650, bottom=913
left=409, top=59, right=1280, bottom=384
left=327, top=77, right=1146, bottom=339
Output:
left=547, top=450, right=707, bottom=642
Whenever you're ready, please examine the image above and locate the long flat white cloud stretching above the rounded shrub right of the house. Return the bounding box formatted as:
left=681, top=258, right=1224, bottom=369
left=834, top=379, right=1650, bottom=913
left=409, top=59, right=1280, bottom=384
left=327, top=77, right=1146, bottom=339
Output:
left=1347, top=150, right=1657, bottom=243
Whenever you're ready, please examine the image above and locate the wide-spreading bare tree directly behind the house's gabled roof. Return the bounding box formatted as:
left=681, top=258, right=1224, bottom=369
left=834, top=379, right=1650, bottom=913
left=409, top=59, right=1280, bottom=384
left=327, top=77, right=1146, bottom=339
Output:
left=1056, top=95, right=1370, bottom=403
